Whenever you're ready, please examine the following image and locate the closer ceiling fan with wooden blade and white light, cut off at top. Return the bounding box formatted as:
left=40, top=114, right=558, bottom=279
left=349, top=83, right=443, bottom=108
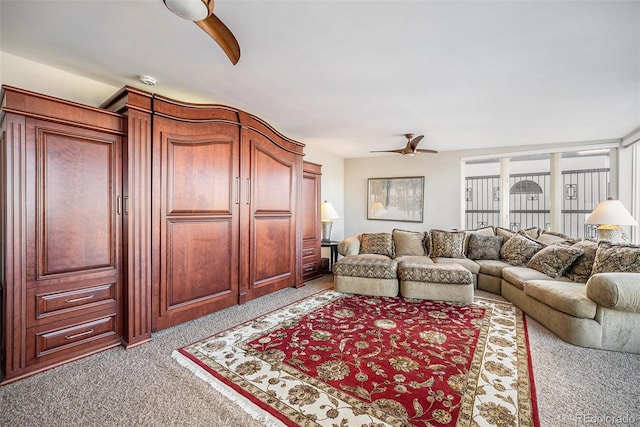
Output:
left=163, top=0, right=240, bottom=65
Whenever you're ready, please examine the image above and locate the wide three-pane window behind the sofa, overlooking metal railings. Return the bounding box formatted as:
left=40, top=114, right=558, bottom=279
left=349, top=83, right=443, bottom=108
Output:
left=464, top=149, right=610, bottom=237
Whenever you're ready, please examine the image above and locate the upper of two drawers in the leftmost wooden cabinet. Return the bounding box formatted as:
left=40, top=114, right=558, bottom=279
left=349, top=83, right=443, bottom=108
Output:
left=27, top=283, right=118, bottom=326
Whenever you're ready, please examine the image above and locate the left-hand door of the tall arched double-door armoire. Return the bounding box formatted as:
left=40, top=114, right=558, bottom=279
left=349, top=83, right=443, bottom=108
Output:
left=152, top=116, right=240, bottom=330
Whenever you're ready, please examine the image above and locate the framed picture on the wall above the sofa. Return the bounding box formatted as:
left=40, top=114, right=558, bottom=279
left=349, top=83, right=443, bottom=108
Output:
left=367, top=176, right=424, bottom=222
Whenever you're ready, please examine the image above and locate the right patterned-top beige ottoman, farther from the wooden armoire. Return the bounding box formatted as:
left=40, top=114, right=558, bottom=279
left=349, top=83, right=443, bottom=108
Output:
left=398, top=261, right=473, bottom=303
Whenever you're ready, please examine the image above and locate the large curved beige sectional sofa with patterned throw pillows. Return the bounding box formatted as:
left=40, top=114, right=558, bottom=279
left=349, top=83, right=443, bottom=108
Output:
left=334, top=227, right=640, bottom=353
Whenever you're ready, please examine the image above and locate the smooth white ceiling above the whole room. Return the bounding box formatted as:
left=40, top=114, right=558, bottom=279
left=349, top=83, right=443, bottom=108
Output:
left=0, top=0, right=640, bottom=158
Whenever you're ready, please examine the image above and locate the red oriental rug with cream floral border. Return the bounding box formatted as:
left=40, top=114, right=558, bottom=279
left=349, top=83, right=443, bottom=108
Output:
left=173, top=291, right=539, bottom=427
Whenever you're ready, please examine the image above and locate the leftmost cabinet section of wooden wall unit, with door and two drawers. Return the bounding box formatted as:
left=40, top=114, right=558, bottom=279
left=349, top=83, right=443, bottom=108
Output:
left=1, top=87, right=124, bottom=382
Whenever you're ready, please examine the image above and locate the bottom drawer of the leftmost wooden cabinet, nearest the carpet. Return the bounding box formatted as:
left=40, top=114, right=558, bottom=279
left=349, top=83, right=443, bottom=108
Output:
left=28, top=313, right=119, bottom=362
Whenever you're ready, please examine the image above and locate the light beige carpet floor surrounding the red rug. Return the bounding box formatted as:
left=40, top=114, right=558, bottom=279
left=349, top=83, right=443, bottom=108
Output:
left=0, top=275, right=640, bottom=427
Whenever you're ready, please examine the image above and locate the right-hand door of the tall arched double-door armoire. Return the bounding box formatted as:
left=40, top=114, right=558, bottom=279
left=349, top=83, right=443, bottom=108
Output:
left=240, top=130, right=302, bottom=303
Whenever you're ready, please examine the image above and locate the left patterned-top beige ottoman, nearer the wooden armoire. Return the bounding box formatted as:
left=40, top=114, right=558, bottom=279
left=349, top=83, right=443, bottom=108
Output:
left=333, top=254, right=398, bottom=297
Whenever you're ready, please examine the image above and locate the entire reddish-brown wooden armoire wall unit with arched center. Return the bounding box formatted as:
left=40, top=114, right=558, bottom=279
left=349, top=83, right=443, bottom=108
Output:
left=0, top=86, right=312, bottom=383
